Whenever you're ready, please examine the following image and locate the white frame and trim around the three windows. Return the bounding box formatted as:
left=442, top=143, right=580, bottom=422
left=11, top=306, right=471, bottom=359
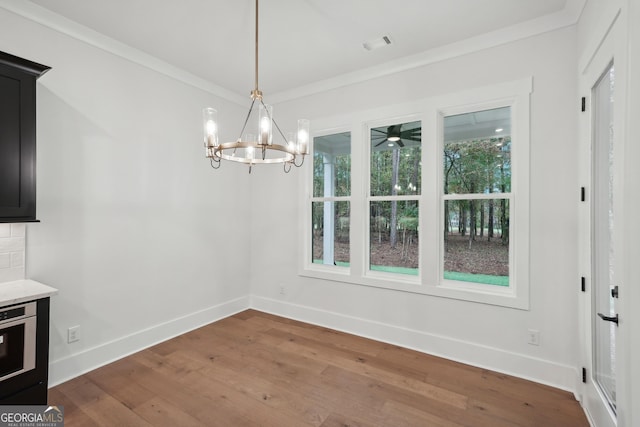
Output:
left=298, top=77, right=533, bottom=310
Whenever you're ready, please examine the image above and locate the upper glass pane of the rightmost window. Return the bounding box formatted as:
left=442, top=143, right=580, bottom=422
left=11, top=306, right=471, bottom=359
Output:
left=443, top=107, right=511, bottom=194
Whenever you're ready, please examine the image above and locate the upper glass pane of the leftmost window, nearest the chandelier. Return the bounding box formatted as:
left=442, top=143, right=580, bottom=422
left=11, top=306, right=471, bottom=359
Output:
left=313, top=132, right=351, bottom=197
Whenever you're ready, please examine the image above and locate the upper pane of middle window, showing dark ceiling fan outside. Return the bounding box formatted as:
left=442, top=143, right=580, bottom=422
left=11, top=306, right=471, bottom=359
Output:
left=371, top=121, right=422, bottom=196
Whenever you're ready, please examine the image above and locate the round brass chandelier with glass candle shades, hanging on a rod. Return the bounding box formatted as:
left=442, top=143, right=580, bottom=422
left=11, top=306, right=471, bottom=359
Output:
left=202, top=0, right=309, bottom=173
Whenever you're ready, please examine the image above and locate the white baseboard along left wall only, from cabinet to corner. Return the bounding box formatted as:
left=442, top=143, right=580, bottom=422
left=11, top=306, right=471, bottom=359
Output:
left=49, top=296, right=250, bottom=387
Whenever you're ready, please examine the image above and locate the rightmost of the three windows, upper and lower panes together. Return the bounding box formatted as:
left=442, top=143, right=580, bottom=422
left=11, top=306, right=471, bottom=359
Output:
left=442, top=106, right=512, bottom=286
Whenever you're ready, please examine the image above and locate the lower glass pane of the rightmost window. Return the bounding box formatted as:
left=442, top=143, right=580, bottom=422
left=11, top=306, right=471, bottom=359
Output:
left=444, top=199, right=510, bottom=286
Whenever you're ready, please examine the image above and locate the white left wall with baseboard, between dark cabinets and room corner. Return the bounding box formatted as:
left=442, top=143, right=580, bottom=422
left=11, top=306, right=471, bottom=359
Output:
left=0, top=8, right=250, bottom=384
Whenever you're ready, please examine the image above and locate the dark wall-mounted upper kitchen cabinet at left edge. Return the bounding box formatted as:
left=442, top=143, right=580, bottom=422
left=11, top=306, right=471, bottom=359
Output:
left=0, top=52, right=49, bottom=222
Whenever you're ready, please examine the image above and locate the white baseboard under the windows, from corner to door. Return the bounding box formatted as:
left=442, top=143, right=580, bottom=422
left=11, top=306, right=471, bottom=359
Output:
left=251, top=295, right=578, bottom=395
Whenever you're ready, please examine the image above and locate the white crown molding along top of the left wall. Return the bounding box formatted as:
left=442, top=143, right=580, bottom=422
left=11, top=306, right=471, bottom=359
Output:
left=0, top=0, right=247, bottom=106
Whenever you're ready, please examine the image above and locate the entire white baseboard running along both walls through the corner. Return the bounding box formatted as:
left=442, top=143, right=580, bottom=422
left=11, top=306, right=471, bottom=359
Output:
left=49, top=295, right=578, bottom=394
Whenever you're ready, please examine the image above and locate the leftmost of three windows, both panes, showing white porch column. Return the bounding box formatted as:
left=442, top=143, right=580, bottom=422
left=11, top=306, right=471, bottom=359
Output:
left=311, top=132, right=351, bottom=267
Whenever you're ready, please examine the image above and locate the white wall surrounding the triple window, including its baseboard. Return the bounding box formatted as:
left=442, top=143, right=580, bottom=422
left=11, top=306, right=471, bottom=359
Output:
left=251, top=28, right=579, bottom=390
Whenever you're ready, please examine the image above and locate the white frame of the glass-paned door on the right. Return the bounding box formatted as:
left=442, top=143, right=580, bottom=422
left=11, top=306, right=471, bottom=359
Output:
left=577, top=7, right=629, bottom=427
